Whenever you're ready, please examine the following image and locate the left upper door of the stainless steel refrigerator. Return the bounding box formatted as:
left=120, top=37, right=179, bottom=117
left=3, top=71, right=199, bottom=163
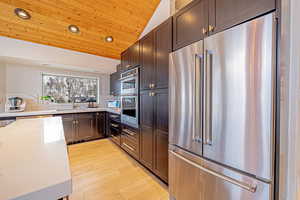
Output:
left=169, top=41, right=204, bottom=155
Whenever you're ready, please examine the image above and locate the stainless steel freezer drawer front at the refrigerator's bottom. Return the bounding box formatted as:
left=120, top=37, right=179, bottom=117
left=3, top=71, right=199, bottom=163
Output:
left=169, top=147, right=272, bottom=200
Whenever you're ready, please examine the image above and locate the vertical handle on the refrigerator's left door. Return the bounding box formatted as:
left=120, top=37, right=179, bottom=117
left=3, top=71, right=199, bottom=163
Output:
left=193, top=54, right=204, bottom=143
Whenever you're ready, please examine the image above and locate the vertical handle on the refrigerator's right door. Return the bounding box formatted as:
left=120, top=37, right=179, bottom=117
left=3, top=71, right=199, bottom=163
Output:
left=204, top=50, right=213, bottom=145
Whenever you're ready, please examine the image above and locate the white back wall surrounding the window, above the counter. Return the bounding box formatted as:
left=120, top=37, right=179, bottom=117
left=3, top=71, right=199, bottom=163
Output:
left=5, top=64, right=110, bottom=111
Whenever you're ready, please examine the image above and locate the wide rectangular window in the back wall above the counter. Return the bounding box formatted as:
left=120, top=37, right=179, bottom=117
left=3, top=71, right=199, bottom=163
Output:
left=43, top=74, right=99, bottom=103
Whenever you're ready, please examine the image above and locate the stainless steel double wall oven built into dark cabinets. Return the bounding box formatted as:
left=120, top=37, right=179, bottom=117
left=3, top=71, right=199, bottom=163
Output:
left=121, top=68, right=139, bottom=128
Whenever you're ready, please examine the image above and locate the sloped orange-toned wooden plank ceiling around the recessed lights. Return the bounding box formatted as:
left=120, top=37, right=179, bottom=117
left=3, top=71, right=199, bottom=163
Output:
left=0, top=0, right=160, bottom=59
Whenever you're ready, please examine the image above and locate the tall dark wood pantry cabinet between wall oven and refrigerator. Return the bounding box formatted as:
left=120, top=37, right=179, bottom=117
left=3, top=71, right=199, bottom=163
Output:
left=140, top=18, right=172, bottom=182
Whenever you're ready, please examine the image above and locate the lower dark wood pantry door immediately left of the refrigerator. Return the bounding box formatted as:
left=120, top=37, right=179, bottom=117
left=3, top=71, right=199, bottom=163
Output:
left=153, top=89, right=169, bottom=182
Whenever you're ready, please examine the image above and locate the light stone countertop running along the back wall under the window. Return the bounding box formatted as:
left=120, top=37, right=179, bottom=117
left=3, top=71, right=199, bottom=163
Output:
left=0, top=108, right=120, bottom=118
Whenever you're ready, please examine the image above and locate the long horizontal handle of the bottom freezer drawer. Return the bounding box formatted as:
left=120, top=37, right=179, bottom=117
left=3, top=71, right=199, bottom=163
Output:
left=170, top=151, right=257, bottom=193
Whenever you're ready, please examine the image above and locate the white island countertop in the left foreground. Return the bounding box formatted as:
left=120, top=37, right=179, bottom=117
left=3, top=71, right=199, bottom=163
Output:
left=0, top=117, right=72, bottom=200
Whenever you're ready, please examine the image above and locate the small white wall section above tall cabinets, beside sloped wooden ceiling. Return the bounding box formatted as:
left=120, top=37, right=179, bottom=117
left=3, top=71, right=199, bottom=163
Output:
left=140, top=0, right=171, bottom=38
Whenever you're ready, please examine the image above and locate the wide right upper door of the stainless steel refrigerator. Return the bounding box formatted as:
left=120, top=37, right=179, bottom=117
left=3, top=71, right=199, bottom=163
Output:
left=203, top=14, right=276, bottom=180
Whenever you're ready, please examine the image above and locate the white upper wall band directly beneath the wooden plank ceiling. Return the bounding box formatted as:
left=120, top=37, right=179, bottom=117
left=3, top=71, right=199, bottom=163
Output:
left=0, top=36, right=120, bottom=73
